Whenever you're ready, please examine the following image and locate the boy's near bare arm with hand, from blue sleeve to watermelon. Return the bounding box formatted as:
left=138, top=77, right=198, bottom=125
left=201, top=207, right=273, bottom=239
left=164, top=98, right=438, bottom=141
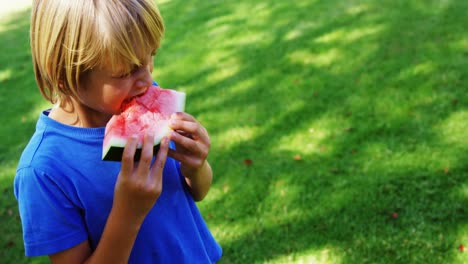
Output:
left=49, top=136, right=169, bottom=264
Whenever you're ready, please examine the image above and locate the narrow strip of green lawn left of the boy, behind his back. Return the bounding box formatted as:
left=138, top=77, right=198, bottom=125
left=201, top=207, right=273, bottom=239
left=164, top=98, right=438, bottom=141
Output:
left=0, top=7, right=46, bottom=263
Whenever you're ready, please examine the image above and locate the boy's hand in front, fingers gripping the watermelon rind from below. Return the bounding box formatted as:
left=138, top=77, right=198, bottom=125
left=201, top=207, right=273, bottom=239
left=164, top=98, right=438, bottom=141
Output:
left=113, top=135, right=169, bottom=224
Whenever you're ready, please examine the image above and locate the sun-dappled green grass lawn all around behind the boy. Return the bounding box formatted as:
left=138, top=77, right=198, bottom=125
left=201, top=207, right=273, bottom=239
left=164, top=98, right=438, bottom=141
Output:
left=0, top=0, right=468, bottom=263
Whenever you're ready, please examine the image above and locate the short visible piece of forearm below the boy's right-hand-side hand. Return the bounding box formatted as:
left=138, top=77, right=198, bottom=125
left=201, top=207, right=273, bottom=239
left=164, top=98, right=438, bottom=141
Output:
left=181, top=161, right=213, bottom=201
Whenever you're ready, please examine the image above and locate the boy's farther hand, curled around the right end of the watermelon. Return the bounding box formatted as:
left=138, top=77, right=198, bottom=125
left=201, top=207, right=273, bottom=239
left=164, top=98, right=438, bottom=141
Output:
left=168, top=112, right=211, bottom=172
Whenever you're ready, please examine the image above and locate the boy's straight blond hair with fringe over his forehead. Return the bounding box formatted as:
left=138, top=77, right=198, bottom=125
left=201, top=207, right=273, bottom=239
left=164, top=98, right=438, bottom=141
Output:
left=30, top=0, right=164, bottom=105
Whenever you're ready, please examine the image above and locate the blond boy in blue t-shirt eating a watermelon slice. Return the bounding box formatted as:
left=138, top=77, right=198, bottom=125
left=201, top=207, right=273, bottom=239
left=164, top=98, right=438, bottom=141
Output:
left=14, top=0, right=222, bottom=263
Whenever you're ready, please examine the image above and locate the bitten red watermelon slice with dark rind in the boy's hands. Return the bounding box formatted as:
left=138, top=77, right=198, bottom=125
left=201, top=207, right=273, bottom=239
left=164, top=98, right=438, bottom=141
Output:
left=102, top=86, right=185, bottom=161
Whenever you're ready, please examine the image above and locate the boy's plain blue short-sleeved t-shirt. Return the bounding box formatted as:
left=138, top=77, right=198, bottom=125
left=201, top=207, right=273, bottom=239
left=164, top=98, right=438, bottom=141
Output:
left=14, top=111, right=222, bottom=263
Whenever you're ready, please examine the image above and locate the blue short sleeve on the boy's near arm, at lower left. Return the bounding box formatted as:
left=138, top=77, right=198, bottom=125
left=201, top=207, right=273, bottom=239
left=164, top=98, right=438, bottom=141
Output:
left=14, top=167, right=88, bottom=256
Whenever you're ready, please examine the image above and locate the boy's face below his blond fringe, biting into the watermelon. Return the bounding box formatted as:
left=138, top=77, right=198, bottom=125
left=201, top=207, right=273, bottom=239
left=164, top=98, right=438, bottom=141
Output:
left=78, top=54, right=153, bottom=118
